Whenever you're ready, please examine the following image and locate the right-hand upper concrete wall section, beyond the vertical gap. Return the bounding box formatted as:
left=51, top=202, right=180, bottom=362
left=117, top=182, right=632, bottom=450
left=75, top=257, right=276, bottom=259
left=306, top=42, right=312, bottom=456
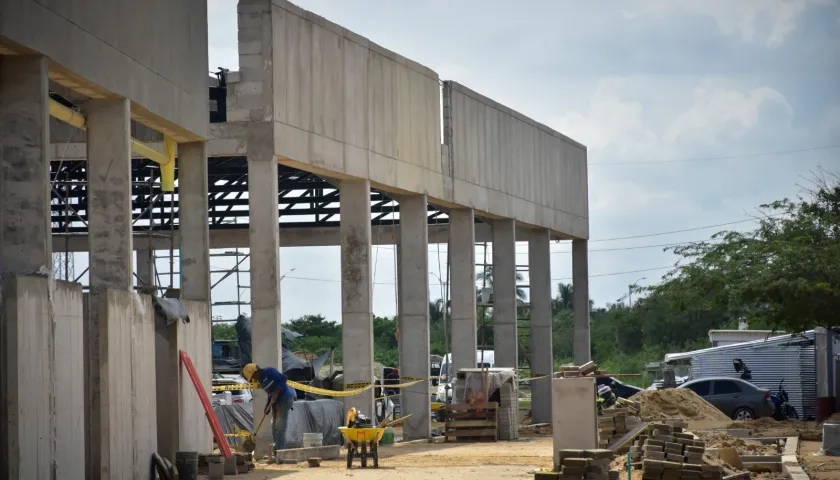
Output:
left=443, top=81, right=589, bottom=239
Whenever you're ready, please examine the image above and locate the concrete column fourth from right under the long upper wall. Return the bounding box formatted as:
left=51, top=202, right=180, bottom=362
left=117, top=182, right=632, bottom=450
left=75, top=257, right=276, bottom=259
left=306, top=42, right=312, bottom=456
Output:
left=449, top=208, right=478, bottom=374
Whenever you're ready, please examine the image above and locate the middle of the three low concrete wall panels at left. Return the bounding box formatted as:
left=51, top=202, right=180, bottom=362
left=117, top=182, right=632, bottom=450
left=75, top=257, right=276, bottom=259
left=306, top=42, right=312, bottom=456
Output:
left=85, top=290, right=157, bottom=479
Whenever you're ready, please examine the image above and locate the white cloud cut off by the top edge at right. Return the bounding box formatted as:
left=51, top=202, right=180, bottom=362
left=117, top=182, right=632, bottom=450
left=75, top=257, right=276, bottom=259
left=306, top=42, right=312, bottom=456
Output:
left=643, top=0, right=820, bottom=48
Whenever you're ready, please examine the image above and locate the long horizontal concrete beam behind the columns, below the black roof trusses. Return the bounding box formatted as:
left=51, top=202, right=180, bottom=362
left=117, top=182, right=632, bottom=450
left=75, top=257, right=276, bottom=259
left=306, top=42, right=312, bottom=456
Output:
left=52, top=223, right=492, bottom=253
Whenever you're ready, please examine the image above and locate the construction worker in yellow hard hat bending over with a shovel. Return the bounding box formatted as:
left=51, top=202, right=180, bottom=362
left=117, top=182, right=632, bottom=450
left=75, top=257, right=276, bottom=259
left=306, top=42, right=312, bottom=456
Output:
left=242, top=363, right=296, bottom=450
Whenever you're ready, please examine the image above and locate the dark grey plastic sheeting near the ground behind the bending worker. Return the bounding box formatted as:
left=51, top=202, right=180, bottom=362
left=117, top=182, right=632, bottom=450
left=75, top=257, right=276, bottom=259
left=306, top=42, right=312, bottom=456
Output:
left=213, top=399, right=344, bottom=448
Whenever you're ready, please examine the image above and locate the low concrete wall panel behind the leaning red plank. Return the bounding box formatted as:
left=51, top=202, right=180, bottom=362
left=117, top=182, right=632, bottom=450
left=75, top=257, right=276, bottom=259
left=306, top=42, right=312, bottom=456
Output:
left=155, top=300, right=213, bottom=462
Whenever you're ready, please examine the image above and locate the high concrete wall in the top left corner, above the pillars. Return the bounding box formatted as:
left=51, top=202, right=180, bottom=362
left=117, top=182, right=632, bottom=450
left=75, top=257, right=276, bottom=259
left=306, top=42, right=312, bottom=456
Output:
left=0, top=0, right=209, bottom=141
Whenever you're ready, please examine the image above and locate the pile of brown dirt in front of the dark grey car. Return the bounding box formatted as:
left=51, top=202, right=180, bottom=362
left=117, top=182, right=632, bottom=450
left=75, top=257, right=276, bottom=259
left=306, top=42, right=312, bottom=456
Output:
left=632, top=388, right=729, bottom=421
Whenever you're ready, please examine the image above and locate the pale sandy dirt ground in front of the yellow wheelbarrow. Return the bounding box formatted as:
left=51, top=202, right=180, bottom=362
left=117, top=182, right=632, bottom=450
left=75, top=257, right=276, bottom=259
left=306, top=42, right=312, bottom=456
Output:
left=213, top=436, right=552, bottom=480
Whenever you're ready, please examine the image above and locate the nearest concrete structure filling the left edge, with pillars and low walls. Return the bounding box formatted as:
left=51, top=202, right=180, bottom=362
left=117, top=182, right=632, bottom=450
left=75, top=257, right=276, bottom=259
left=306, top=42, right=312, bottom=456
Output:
left=0, top=0, right=211, bottom=479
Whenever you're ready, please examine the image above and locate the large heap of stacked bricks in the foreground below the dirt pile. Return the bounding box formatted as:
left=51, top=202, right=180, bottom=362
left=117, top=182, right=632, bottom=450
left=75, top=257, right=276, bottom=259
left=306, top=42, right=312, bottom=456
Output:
left=630, top=420, right=723, bottom=480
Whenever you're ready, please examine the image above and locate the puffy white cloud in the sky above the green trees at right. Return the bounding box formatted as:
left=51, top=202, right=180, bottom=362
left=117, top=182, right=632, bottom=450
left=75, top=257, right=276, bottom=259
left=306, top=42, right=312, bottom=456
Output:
left=664, top=86, right=793, bottom=143
